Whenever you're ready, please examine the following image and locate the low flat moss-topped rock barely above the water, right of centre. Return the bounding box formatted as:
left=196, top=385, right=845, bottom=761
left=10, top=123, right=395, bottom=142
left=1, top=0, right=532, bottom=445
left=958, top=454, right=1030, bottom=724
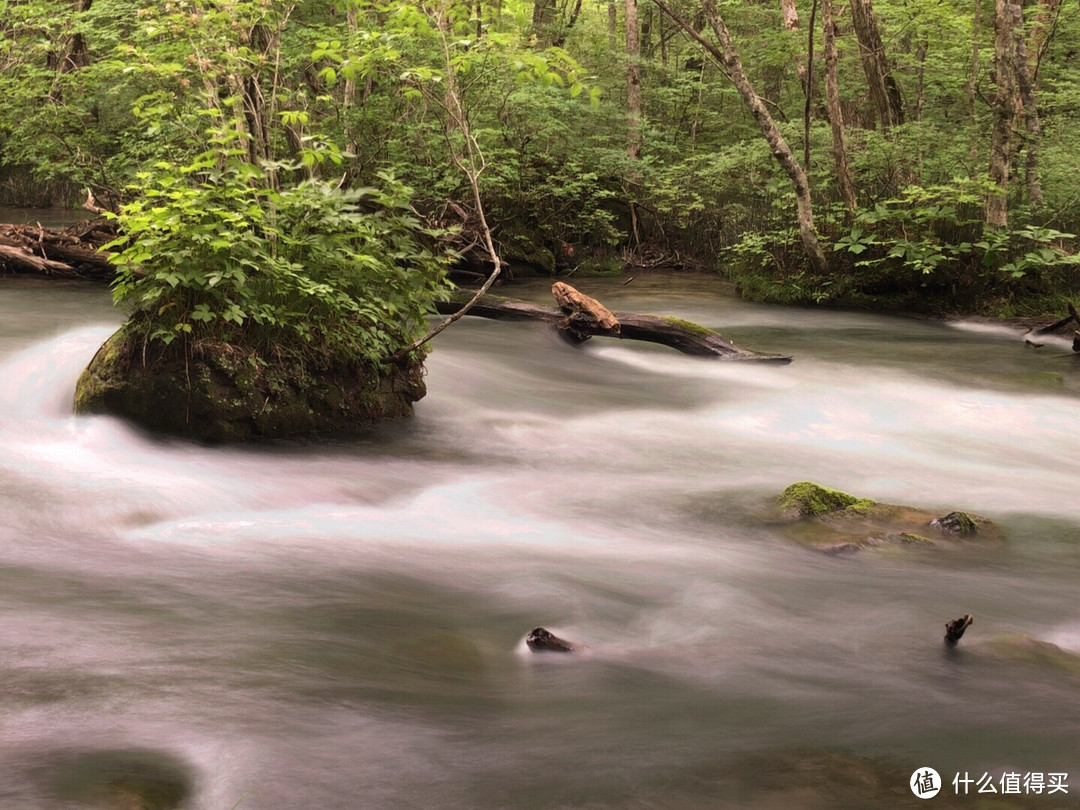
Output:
left=777, top=481, right=1002, bottom=554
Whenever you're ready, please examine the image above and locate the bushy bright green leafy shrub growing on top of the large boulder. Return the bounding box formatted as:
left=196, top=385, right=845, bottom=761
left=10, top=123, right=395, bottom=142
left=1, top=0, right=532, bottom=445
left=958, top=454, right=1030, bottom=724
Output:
left=107, top=146, right=447, bottom=362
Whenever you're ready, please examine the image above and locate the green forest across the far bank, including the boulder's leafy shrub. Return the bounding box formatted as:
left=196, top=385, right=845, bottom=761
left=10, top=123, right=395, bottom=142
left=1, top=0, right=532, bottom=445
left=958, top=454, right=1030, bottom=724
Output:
left=0, top=0, right=1080, bottom=339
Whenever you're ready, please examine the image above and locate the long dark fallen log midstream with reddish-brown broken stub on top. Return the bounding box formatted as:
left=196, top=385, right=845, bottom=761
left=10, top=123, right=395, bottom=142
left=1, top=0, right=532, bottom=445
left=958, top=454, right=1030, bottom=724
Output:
left=438, top=282, right=792, bottom=363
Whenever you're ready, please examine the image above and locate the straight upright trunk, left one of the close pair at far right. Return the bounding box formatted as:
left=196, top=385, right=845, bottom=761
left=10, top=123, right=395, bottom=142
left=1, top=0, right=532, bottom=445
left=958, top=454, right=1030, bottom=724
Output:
left=986, top=0, right=1020, bottom=228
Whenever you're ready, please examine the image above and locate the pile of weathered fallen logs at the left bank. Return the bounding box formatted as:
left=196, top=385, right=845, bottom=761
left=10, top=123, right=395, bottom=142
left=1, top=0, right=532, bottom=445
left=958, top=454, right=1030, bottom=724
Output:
left=0, top=222, right=117, bottom=281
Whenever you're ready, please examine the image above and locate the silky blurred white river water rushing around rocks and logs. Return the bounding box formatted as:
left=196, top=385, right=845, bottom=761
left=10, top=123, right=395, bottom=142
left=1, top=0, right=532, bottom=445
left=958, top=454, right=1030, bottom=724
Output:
left=0, top=275, right=1080, bottom=810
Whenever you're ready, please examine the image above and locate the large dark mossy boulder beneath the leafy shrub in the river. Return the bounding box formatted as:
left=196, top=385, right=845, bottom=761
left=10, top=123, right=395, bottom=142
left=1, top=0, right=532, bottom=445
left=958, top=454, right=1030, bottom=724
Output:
left=75, top=325, right=427, bottom=443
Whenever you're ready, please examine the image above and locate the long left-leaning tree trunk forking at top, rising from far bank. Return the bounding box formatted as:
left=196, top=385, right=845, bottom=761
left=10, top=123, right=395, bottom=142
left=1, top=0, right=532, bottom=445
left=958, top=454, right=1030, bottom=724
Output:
left=652, top=0, right=827, bottom=272
